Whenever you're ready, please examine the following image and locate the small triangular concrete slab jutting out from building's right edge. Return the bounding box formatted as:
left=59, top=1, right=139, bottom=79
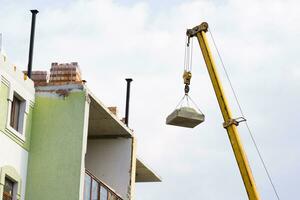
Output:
left=135, top=159, right=161, bottom=182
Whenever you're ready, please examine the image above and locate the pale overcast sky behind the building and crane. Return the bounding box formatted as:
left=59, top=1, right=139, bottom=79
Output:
left=0, top=0, right=300, bottom=200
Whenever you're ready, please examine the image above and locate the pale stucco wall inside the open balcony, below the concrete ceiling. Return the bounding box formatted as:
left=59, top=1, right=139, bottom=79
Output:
left=85, top=138, right=132, bottom=199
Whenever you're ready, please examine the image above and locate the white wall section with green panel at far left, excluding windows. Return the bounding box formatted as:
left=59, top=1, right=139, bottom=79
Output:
left=0, top=55, right=34, bottom=200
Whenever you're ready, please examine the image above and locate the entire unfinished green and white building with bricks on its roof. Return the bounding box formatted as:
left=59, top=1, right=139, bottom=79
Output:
left=0, top=56, right=160, bottom=200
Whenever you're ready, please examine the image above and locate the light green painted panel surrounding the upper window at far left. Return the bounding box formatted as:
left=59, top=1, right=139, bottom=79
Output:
left=0, top=82, right=33, bottom=151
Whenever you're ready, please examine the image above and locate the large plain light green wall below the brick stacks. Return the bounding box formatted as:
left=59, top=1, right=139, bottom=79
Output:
left=25, top=91, right=86, bottom=200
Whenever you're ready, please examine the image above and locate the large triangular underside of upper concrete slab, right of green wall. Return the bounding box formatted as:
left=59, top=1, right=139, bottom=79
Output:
left=88, top=92, right=132, bottom=139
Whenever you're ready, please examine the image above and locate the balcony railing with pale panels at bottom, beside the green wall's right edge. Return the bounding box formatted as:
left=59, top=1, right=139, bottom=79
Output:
left=83, top=170, right=123, bottom=200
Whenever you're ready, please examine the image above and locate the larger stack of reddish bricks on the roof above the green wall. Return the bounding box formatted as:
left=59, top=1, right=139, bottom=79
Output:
left=49, top=62, right=82, bottom=85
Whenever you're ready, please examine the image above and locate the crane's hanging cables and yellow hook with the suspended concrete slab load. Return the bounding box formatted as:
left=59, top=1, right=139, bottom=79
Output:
left=166, top=36, right=205, bottom=128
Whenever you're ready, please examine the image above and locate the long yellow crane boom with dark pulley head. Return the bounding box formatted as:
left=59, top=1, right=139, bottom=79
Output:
left=187, top=22, right=260, bottom=200
